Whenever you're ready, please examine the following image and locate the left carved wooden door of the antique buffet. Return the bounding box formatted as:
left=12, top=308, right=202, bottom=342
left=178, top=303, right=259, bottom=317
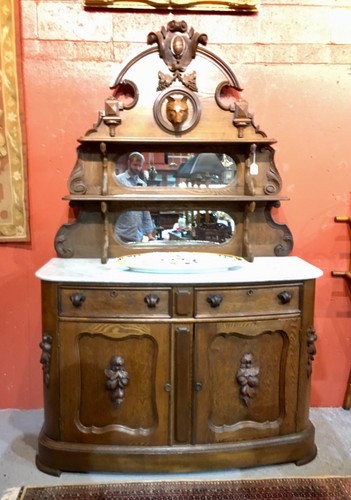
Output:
left=59, top=322, right=170, bottom=445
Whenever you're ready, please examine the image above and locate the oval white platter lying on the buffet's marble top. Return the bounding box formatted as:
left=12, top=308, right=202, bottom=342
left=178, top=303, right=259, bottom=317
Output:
left=116, top=252, right=245, bottom=274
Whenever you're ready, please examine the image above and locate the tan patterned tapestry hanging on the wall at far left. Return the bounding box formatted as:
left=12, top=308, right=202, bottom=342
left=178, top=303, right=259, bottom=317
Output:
left=0, top=0, right=30, bottom=242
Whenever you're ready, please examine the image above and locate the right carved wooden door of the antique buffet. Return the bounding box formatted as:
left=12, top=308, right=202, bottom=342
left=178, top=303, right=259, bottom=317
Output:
left=193, top=316, right=300, bottom=443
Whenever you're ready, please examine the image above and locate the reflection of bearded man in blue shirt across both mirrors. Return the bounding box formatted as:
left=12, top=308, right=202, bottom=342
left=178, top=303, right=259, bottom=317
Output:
left=115, top=152, right=155, bottom=242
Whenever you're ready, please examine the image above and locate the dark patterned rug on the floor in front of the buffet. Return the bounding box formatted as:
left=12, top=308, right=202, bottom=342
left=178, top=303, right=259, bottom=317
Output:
left=6, top=477, right=351, bottom=500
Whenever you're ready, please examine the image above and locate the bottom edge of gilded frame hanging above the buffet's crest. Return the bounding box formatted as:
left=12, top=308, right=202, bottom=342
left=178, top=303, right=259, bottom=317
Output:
left=83, top=0, right=259, bottom=14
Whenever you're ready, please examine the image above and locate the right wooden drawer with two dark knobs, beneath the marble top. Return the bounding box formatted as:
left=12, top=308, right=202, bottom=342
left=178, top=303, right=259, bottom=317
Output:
left=195, top=285, right=300, bottom=318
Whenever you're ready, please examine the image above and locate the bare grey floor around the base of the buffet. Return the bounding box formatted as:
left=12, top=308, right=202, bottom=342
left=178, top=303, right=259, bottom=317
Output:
left=0, top=408, right=351, bottom=494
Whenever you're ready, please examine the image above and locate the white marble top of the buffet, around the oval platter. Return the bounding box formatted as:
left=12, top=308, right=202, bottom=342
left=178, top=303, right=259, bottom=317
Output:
left=36, top=257, right=323, bottom=285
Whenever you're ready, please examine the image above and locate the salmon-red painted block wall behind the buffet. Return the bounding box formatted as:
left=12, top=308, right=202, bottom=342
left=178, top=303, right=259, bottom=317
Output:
left=0, top=0, right=351, bottom=409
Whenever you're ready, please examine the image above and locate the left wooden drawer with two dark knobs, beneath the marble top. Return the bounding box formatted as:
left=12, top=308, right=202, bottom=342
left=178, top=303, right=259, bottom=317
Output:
left=58, top=286, right=171, bottom=318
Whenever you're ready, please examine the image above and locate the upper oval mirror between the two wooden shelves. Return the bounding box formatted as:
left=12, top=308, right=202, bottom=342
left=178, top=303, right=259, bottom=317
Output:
left=114, top=152, right=237, bottom=188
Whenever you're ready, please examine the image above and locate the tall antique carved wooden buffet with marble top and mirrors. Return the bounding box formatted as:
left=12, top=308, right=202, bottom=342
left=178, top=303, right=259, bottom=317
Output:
left=37, top=20, right=321, bottom=475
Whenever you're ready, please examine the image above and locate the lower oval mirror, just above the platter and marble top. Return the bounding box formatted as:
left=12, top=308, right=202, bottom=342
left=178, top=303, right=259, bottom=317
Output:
left=115, top=210, right=235, bottom=245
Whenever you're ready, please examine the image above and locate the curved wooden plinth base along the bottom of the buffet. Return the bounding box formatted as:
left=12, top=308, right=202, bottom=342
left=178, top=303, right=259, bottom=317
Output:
left=36, top=422, right=317, bottom=476
